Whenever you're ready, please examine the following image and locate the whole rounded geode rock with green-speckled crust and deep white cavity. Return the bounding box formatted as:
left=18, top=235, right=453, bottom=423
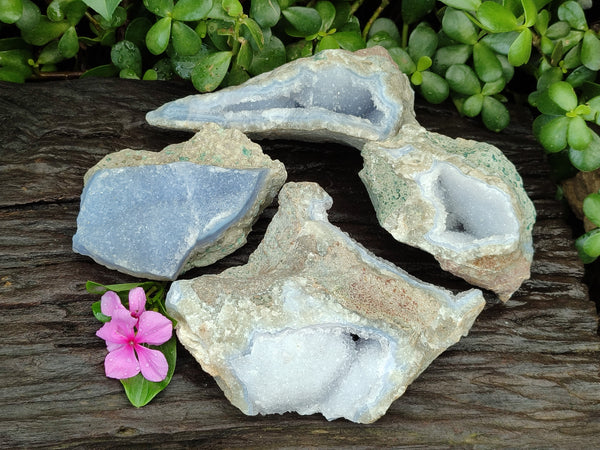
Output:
left=359, top=125, right=535, bottom=301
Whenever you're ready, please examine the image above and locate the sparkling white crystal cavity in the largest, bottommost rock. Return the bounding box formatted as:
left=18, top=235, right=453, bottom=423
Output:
left=231, top=324, right=396, bottom=420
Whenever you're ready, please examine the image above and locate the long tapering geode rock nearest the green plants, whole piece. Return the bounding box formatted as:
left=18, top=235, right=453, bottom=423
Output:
left=146, top=47, right=415, bottom=148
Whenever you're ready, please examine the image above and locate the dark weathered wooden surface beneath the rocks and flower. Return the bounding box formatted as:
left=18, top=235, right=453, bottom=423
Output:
left=0, top=79, right=600, bottom=448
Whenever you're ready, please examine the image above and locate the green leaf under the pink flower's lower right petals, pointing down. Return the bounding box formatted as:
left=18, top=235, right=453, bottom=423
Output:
left=121, top=336, right=177, bottom=408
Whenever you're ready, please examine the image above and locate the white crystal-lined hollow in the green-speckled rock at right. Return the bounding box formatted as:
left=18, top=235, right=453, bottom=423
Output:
left=415, top=161, right=519, bottom=251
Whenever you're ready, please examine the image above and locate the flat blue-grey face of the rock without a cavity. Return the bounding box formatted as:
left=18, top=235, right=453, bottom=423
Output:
left=73, top=162, right=267, bottom=279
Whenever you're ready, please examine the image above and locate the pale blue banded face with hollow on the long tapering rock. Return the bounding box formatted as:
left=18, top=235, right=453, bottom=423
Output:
left=147, top=67, right=402, bottom=139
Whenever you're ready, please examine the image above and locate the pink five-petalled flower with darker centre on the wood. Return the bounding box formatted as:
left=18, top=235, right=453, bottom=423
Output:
left=96, top=288, right=173, bottom=381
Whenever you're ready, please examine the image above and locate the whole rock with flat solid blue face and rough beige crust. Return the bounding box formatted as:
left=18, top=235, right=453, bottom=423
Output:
left=73, top=124, right=287, bottom=280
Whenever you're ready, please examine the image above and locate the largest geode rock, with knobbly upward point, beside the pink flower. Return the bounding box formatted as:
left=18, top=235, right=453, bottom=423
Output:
left=166, top=183, right=484, bottom=423
